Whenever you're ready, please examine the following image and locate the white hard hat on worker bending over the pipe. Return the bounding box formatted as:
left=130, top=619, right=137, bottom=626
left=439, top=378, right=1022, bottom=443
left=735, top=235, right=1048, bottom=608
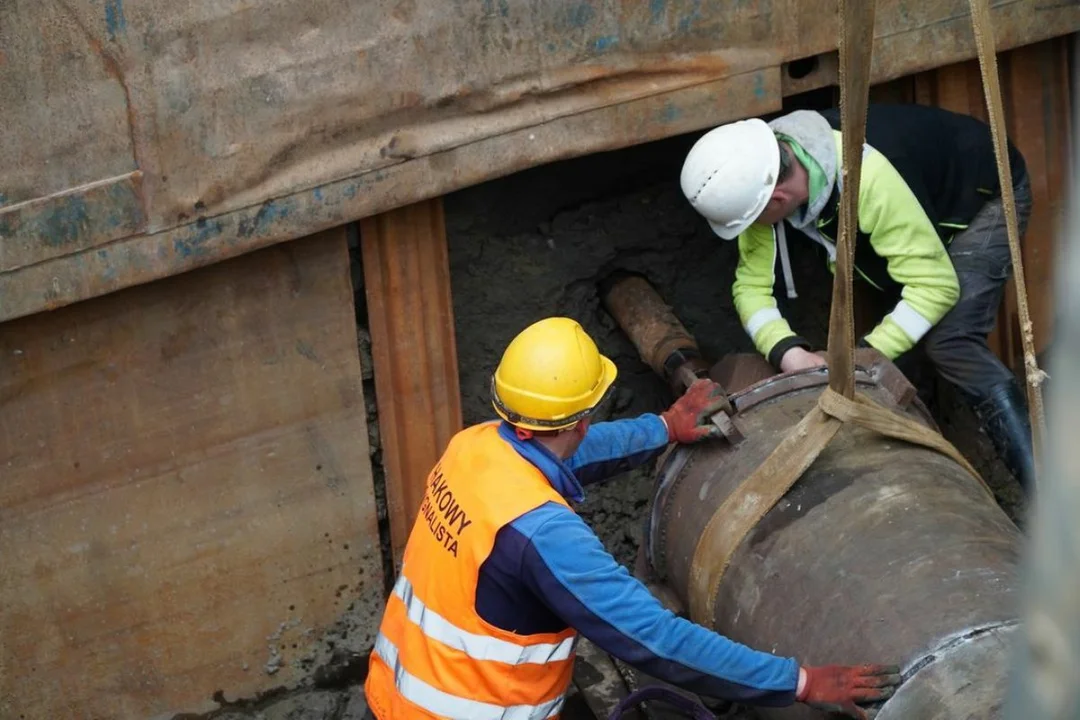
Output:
left=679, top=118, right=780, bottom=240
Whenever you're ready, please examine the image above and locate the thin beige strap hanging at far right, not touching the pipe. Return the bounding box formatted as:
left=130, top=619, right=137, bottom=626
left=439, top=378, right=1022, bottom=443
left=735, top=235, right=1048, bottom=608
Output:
left=969, top=0, right=1047, bottom=478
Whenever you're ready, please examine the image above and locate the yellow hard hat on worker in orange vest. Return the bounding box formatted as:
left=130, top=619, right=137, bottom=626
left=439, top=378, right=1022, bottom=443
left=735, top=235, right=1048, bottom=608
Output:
left=491, top=317, right=618, bottom=431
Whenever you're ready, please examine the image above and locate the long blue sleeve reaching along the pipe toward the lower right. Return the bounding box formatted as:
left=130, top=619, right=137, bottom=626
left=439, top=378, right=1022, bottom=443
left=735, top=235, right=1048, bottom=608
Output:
left=512, top=503, right=799, bottom=707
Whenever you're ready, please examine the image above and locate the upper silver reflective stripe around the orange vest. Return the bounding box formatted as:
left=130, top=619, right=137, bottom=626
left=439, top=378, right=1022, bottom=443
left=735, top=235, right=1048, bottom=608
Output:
left=394, top=568, right=577, bottom=665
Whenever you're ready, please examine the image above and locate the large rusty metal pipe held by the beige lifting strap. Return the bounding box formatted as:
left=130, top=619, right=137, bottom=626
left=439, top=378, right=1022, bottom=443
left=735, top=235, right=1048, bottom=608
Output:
left=604, top=274, right=1021, bottom=720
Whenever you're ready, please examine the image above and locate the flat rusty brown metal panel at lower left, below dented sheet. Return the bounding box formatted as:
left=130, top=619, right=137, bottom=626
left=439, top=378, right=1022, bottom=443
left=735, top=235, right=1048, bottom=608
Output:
left=0, top=231, right=383, bottom=718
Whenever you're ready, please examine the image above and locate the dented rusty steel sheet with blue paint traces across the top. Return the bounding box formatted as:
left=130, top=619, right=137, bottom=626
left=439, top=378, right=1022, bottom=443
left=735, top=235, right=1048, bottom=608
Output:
left=0, top=0, right=1080, bottom=321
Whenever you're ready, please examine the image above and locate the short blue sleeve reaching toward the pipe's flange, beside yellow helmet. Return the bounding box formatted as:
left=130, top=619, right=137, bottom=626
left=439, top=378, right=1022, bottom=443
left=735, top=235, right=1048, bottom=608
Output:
left=566, top=412, right=667, bottom=485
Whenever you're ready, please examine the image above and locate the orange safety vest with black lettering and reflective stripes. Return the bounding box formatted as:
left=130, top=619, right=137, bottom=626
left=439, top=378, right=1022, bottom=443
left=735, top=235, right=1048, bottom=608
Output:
left=364, top=423, right=577, bottom=720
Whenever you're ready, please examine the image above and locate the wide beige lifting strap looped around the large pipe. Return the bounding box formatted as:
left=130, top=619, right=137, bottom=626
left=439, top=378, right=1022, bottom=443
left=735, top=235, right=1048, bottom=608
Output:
left=689, top=0, right=990, bottom=627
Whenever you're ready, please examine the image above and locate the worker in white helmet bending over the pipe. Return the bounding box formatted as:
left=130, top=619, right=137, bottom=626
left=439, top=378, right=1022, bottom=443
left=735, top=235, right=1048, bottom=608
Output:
left=680, top=105, right=1034, bottom=500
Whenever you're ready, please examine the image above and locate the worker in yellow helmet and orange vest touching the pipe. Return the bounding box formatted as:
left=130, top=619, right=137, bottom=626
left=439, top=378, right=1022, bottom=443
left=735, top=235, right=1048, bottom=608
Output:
left=365, top=317, right=899, bottom=720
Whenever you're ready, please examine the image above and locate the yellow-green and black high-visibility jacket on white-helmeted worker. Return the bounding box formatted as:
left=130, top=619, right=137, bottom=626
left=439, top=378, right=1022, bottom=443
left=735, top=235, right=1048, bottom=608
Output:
left=732, top=106, right=1026, bottom=367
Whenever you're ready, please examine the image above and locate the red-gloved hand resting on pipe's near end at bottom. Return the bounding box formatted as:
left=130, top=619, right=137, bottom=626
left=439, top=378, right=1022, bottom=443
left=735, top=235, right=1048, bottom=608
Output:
left=795, top=665, right=900, bottom=720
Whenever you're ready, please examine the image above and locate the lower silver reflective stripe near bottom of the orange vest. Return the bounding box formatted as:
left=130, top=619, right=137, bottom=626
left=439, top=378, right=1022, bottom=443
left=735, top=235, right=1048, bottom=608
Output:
left=374, top=633, right=565, bottom=720
